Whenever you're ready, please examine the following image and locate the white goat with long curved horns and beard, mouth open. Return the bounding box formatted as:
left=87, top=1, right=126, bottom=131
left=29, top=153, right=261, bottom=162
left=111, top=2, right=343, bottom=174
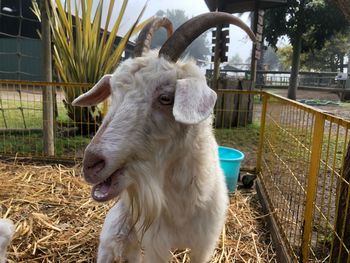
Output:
left=73, top=12, right=254, bottom=263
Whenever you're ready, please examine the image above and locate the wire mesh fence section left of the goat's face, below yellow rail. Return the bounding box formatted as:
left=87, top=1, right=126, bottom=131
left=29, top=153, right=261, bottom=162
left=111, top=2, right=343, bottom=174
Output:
left=0, top=81, right=95, bottom=159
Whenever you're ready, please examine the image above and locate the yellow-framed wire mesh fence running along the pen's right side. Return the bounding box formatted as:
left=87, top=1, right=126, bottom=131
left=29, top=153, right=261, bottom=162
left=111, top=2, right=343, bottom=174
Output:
left=261, top=92, right=350, bottom=262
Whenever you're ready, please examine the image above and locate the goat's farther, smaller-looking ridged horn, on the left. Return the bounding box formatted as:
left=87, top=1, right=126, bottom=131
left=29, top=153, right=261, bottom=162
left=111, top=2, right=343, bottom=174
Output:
left=134, top=17, right=173, bottom=57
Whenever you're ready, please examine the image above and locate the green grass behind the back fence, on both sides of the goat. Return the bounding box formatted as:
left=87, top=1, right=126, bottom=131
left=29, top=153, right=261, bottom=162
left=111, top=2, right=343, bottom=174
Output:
left=0, top=99, right=259, bottom=160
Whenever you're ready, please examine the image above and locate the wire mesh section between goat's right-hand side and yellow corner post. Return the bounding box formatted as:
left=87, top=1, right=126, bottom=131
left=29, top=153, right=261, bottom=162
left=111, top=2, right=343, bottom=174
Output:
left=214, top=89, right=262, bottom=171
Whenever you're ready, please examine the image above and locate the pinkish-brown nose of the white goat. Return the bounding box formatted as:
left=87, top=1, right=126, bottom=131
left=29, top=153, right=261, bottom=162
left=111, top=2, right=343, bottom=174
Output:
left=83, top=150, right=106, bottom=183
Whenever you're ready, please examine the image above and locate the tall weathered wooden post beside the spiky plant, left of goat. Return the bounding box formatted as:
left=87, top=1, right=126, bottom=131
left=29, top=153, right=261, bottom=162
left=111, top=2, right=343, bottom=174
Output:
left=40, top=0, right=55, bottom=156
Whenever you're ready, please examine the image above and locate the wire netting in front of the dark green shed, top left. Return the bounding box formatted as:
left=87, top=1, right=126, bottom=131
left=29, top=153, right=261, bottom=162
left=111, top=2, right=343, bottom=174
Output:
left=0, top=0, right=42, bottom=80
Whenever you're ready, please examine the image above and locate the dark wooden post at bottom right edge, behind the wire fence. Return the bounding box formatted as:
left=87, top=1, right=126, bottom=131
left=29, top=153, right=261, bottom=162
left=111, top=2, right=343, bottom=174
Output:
left=330, top=142, right=350, bottom=263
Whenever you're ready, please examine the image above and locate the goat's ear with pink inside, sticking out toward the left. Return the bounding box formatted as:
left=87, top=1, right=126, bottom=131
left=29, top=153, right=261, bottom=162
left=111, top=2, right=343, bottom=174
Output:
left=72, top=75, right=112, bottom=107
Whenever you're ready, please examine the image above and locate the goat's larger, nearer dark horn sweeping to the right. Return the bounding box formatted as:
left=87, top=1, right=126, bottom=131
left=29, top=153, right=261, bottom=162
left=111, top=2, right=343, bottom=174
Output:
left=159, top=12, right=255, bottom=62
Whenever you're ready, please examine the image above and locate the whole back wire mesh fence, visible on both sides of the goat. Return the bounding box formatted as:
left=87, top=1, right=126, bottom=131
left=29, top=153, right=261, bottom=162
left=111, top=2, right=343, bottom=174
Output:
left=0, top=80, right=261, bottom=166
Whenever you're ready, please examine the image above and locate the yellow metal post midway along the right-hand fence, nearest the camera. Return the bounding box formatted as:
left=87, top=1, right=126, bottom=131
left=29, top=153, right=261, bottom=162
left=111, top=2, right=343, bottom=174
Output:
left=300, top=112, right=325, bottom=262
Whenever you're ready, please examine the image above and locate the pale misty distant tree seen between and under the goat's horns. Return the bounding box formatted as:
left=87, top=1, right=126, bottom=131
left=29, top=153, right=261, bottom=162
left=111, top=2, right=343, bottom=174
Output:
left=151, top=9, right=210, bottom=61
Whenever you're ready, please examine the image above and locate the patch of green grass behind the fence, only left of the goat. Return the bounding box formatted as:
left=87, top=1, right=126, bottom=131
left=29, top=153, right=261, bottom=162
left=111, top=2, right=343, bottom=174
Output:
left=0, top=96, right=91, bottom=157
